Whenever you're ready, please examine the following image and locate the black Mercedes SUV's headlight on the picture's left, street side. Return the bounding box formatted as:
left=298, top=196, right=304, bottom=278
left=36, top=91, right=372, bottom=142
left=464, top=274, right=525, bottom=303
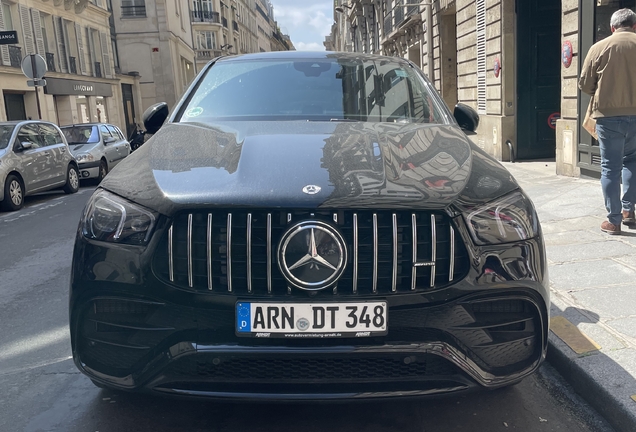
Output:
left=82, top=190, right=157, bottom=245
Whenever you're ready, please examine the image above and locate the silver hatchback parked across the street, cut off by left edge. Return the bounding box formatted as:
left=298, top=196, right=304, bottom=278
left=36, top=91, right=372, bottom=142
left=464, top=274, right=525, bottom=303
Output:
left=0, top=121, right=79, bottom=211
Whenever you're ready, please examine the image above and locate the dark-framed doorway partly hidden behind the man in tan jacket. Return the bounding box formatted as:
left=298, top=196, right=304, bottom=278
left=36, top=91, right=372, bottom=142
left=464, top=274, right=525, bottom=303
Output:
left=577, top=0, right=636, bottom=177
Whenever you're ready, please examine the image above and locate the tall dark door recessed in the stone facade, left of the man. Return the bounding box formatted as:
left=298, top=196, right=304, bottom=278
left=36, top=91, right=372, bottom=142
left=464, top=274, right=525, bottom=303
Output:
left=516, top=0, right=561, bottom=160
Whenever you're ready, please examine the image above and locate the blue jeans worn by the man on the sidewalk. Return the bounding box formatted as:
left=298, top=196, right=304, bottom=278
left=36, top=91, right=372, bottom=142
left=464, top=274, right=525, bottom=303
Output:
left=596, top=116, right=636, bottom=226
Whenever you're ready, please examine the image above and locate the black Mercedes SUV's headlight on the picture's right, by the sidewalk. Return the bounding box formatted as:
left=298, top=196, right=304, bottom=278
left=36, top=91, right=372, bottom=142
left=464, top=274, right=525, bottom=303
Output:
left=464, top=191, right=539, bottom=245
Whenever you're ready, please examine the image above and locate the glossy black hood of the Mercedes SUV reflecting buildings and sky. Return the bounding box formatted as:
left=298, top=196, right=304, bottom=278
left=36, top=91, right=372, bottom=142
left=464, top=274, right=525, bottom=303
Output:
left=102, top=122, right=517, bottom=215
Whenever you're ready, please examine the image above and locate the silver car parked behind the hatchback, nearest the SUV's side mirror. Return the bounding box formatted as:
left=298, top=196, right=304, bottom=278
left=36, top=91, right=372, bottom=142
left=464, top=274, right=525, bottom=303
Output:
left=62, top=123, right=130, bottom=181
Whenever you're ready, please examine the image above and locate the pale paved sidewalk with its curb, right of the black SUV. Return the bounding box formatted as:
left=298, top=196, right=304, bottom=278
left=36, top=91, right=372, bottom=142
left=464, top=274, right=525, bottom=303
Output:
left=503, top=162, right=636, bottom=432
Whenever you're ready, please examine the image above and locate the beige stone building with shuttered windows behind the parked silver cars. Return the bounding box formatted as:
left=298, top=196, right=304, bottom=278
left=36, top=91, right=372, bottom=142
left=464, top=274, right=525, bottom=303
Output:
left=0, top=0, right=139, bottom=136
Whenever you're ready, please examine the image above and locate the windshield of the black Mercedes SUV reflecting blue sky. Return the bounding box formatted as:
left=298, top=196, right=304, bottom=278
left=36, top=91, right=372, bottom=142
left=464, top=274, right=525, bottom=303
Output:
left=179, top=58, right=446, bottom=123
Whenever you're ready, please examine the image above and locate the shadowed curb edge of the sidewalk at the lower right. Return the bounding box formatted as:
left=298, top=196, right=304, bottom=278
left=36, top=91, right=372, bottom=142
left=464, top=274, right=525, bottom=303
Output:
left=547, top=335, right=636, bottom=432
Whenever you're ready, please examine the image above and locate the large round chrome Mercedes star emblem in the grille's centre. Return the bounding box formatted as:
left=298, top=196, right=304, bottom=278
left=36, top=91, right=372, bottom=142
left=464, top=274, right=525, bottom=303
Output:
left=278, top=221, right=347, bottom=291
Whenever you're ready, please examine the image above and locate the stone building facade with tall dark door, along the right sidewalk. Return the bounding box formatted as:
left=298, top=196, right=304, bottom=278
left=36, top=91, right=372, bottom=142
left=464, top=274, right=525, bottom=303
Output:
left=325, top=0, right=636, bottom=176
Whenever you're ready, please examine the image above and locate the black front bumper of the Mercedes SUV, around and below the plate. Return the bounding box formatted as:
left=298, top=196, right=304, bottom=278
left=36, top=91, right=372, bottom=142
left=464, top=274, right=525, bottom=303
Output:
left=72, top=291, right=547, bottom=400
